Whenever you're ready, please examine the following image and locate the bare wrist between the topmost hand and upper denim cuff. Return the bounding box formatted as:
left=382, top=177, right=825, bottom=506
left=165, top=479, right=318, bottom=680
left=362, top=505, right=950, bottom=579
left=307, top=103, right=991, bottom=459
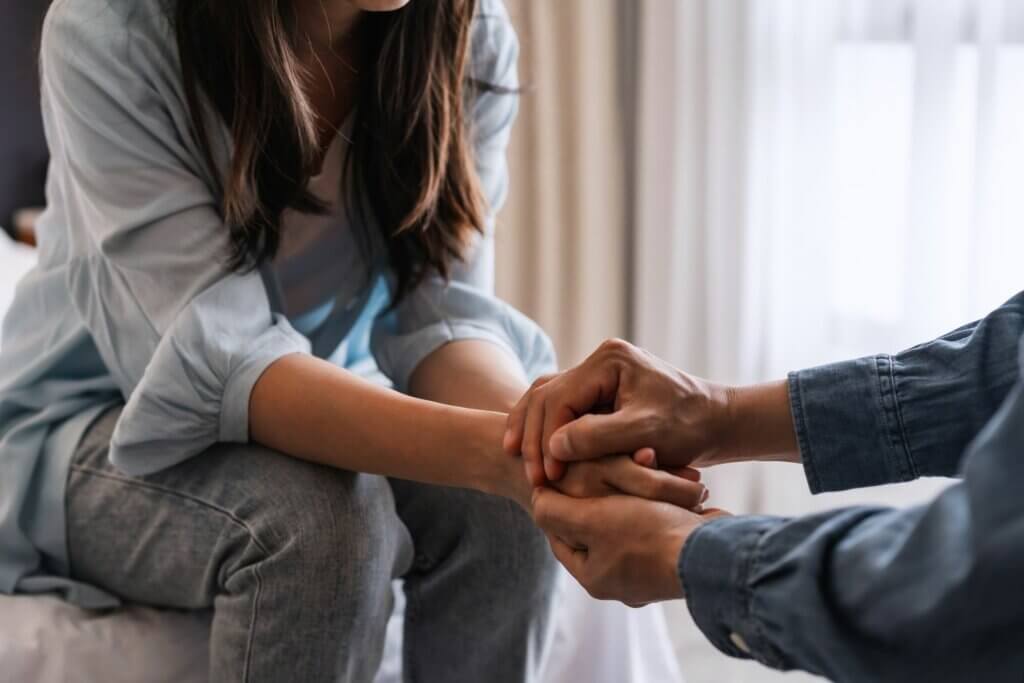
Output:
left=719, top=380, right=800, bottom=463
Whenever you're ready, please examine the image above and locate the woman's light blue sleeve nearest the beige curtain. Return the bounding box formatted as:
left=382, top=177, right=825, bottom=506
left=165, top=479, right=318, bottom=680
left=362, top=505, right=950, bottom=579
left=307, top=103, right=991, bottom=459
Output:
left=371, top=0, right=555, bottom=391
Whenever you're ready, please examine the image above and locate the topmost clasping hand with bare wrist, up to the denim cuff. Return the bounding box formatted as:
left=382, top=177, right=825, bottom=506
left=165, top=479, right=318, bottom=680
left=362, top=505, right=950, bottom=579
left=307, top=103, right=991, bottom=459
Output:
left=504, top=340, right=799, bottom=485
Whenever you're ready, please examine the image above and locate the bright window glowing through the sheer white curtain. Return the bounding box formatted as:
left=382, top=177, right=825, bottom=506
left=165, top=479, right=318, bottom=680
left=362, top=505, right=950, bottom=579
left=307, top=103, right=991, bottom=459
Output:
left=826, top=0, right=1024, bottom=357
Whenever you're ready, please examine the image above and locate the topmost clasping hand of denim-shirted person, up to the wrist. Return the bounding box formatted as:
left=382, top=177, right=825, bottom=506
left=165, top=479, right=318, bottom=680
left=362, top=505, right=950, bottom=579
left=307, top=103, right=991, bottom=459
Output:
left=504, top=340, right=729, bottom=485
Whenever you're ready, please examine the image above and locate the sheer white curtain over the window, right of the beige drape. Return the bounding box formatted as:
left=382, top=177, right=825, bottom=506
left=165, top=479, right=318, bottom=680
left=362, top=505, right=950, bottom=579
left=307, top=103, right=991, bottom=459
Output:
left=634, top=0, right=1024, bottom=681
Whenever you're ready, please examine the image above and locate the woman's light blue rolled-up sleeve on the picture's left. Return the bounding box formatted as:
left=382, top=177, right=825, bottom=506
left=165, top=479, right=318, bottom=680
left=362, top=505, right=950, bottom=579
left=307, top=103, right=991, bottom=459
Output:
left=42, top=3, right=308, bottom=474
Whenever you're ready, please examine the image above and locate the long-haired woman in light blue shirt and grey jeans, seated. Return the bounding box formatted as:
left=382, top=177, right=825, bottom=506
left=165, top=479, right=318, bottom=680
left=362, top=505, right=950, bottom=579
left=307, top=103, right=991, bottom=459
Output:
left=0, top=0, right=699, bottom=681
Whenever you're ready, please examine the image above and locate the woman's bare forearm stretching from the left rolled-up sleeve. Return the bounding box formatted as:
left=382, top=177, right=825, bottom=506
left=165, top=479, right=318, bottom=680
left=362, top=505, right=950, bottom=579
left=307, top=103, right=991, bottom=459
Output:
left=250, top=354, right=529, bottom=503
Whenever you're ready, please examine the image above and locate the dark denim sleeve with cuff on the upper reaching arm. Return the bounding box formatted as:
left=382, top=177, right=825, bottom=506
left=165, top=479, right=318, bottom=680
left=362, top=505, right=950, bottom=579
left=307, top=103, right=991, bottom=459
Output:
left=790, top=293, right=1024, bottom=493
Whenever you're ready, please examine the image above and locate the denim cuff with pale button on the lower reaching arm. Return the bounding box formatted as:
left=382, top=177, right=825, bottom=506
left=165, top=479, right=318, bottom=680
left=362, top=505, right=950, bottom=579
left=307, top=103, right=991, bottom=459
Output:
left=679, top=516, right=784, bottom=669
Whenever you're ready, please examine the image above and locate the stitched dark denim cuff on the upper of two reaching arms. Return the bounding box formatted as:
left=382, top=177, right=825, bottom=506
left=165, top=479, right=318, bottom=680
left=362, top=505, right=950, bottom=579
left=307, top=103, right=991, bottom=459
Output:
left=790, top=355, right=919, bottom=494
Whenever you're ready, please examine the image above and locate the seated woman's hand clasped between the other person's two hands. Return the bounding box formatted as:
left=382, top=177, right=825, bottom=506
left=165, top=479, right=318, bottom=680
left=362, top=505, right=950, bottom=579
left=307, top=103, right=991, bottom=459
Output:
left=551, top=456, right=708, bottom=509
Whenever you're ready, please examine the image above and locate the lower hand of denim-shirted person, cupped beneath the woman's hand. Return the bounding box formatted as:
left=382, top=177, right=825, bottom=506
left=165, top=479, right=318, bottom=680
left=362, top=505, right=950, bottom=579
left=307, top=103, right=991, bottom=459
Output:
left=532, top=487, right=727, bottom=607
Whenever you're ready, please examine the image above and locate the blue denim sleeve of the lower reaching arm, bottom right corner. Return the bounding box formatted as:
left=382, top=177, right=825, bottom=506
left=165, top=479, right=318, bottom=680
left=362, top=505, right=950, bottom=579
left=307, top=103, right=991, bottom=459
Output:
left=680, top=348, right=1024, bottom=683
